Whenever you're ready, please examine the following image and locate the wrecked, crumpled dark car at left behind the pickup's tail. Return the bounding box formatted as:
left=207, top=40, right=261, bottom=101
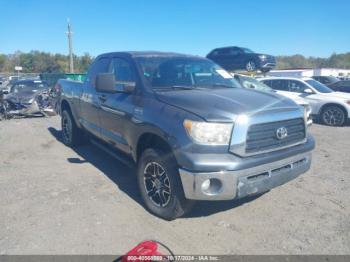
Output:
left=2, top=80, right=54, bottom=118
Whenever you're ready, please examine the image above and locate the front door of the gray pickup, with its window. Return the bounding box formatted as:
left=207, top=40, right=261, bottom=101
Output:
left=100, top=57, right=137, bottom=154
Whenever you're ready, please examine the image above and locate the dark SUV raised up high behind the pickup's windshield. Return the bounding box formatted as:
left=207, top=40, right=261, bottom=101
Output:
left=207, top=46, right=276, bottom=73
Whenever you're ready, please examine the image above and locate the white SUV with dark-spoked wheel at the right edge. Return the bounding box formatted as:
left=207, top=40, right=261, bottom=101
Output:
left=259, top=77, right=350, bottom=126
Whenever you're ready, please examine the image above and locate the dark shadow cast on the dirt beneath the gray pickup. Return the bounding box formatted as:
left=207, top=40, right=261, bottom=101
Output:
left=48, top=127, right=259, bottom=218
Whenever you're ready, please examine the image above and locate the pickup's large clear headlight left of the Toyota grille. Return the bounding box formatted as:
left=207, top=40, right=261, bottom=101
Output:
left=184, top=120, right=233, bottom=145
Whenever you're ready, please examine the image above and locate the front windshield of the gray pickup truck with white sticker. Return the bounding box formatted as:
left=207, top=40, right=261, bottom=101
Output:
left=136, top=56, right=240, bottom=90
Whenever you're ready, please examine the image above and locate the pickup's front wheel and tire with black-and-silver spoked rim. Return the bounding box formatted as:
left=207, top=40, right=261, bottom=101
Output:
left=137, top=149, right=195, bottom=220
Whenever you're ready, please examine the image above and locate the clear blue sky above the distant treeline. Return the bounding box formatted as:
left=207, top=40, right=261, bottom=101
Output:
left=0, top=0, right=350, bottom=57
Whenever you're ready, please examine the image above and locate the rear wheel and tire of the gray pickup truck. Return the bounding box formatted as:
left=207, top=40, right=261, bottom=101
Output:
left=61, top=110, right=85, bottom=147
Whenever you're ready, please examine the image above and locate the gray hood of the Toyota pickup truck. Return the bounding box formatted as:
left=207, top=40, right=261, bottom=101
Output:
left=157, top=88, right=298, bottom=122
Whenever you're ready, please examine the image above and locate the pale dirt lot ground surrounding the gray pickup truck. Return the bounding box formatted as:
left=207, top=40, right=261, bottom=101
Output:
left=0, top=117, right=350, bottom=254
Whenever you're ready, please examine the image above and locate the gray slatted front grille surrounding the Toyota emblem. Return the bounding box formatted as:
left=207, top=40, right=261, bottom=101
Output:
left=245, top=118, right=305, bottom=153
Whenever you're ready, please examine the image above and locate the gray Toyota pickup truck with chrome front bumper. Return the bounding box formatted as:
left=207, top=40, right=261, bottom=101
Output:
left=55, top=52, right=315, bottom=220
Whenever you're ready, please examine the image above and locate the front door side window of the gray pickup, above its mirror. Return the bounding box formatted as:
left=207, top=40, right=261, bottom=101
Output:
left=109, top=58, right=136, bottom=82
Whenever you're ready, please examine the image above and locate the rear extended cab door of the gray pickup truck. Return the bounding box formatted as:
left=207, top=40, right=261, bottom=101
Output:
left=80, top=57, right=110, bottom=137
